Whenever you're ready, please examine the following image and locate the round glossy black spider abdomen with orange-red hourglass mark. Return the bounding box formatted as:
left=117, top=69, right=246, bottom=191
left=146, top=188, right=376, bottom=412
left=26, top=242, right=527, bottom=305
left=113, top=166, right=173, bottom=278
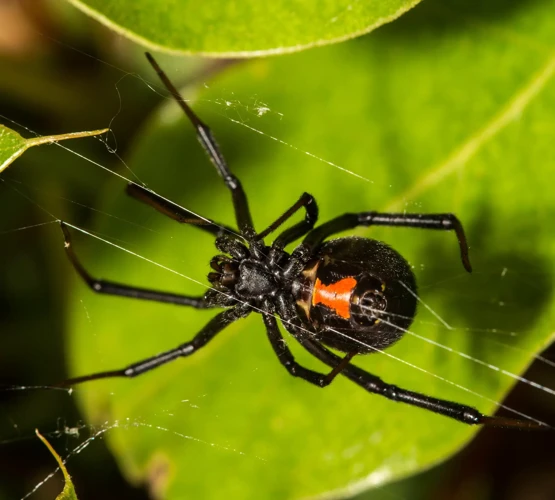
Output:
left=297, top=237, right=417, bottom=353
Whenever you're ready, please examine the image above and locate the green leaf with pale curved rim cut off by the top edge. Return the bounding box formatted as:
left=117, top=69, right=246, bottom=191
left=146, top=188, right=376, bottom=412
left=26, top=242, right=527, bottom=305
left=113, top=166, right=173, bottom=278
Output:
left=65, top=0, right=419, bottom=57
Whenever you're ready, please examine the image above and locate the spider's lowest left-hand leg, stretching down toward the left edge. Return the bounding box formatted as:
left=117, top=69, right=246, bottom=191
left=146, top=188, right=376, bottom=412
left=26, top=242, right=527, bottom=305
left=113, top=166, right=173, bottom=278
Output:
left=58, top=306, right=250, bottom=387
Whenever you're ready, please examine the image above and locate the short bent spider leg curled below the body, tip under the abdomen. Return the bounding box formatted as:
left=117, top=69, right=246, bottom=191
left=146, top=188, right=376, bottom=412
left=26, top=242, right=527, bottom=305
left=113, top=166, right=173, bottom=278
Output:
left=262, top=306, right=356, bottom=387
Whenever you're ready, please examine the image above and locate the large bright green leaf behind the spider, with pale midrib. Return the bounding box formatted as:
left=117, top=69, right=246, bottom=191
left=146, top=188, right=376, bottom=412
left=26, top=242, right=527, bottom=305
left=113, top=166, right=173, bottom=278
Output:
left=68, top=2, right=555, bottom=499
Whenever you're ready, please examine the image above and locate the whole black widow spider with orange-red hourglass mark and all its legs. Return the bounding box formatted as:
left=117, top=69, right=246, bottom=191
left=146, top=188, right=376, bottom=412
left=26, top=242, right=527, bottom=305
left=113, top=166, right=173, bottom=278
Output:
left=61, top=53, right=538, bottom=428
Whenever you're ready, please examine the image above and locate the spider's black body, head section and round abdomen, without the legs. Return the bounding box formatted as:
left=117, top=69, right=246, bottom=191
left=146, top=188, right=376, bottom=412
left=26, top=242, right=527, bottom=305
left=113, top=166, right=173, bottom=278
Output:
left=204, top=235, right=416, bottom=354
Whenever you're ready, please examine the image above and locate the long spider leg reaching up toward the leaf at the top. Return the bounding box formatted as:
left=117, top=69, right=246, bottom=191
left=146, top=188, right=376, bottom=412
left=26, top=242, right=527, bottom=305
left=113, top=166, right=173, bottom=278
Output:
left=145, top=52, right=256, bottom=241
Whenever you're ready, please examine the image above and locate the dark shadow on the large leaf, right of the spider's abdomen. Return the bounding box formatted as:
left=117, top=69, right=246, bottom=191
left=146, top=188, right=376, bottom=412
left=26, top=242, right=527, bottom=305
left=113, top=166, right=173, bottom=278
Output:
left=421, top=200, right=554, bottom=355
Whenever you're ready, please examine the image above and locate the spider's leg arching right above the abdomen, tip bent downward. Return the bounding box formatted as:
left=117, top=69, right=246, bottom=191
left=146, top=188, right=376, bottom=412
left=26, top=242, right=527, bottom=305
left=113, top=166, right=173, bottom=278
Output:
left=286, top=212, right=472, bottom=275
